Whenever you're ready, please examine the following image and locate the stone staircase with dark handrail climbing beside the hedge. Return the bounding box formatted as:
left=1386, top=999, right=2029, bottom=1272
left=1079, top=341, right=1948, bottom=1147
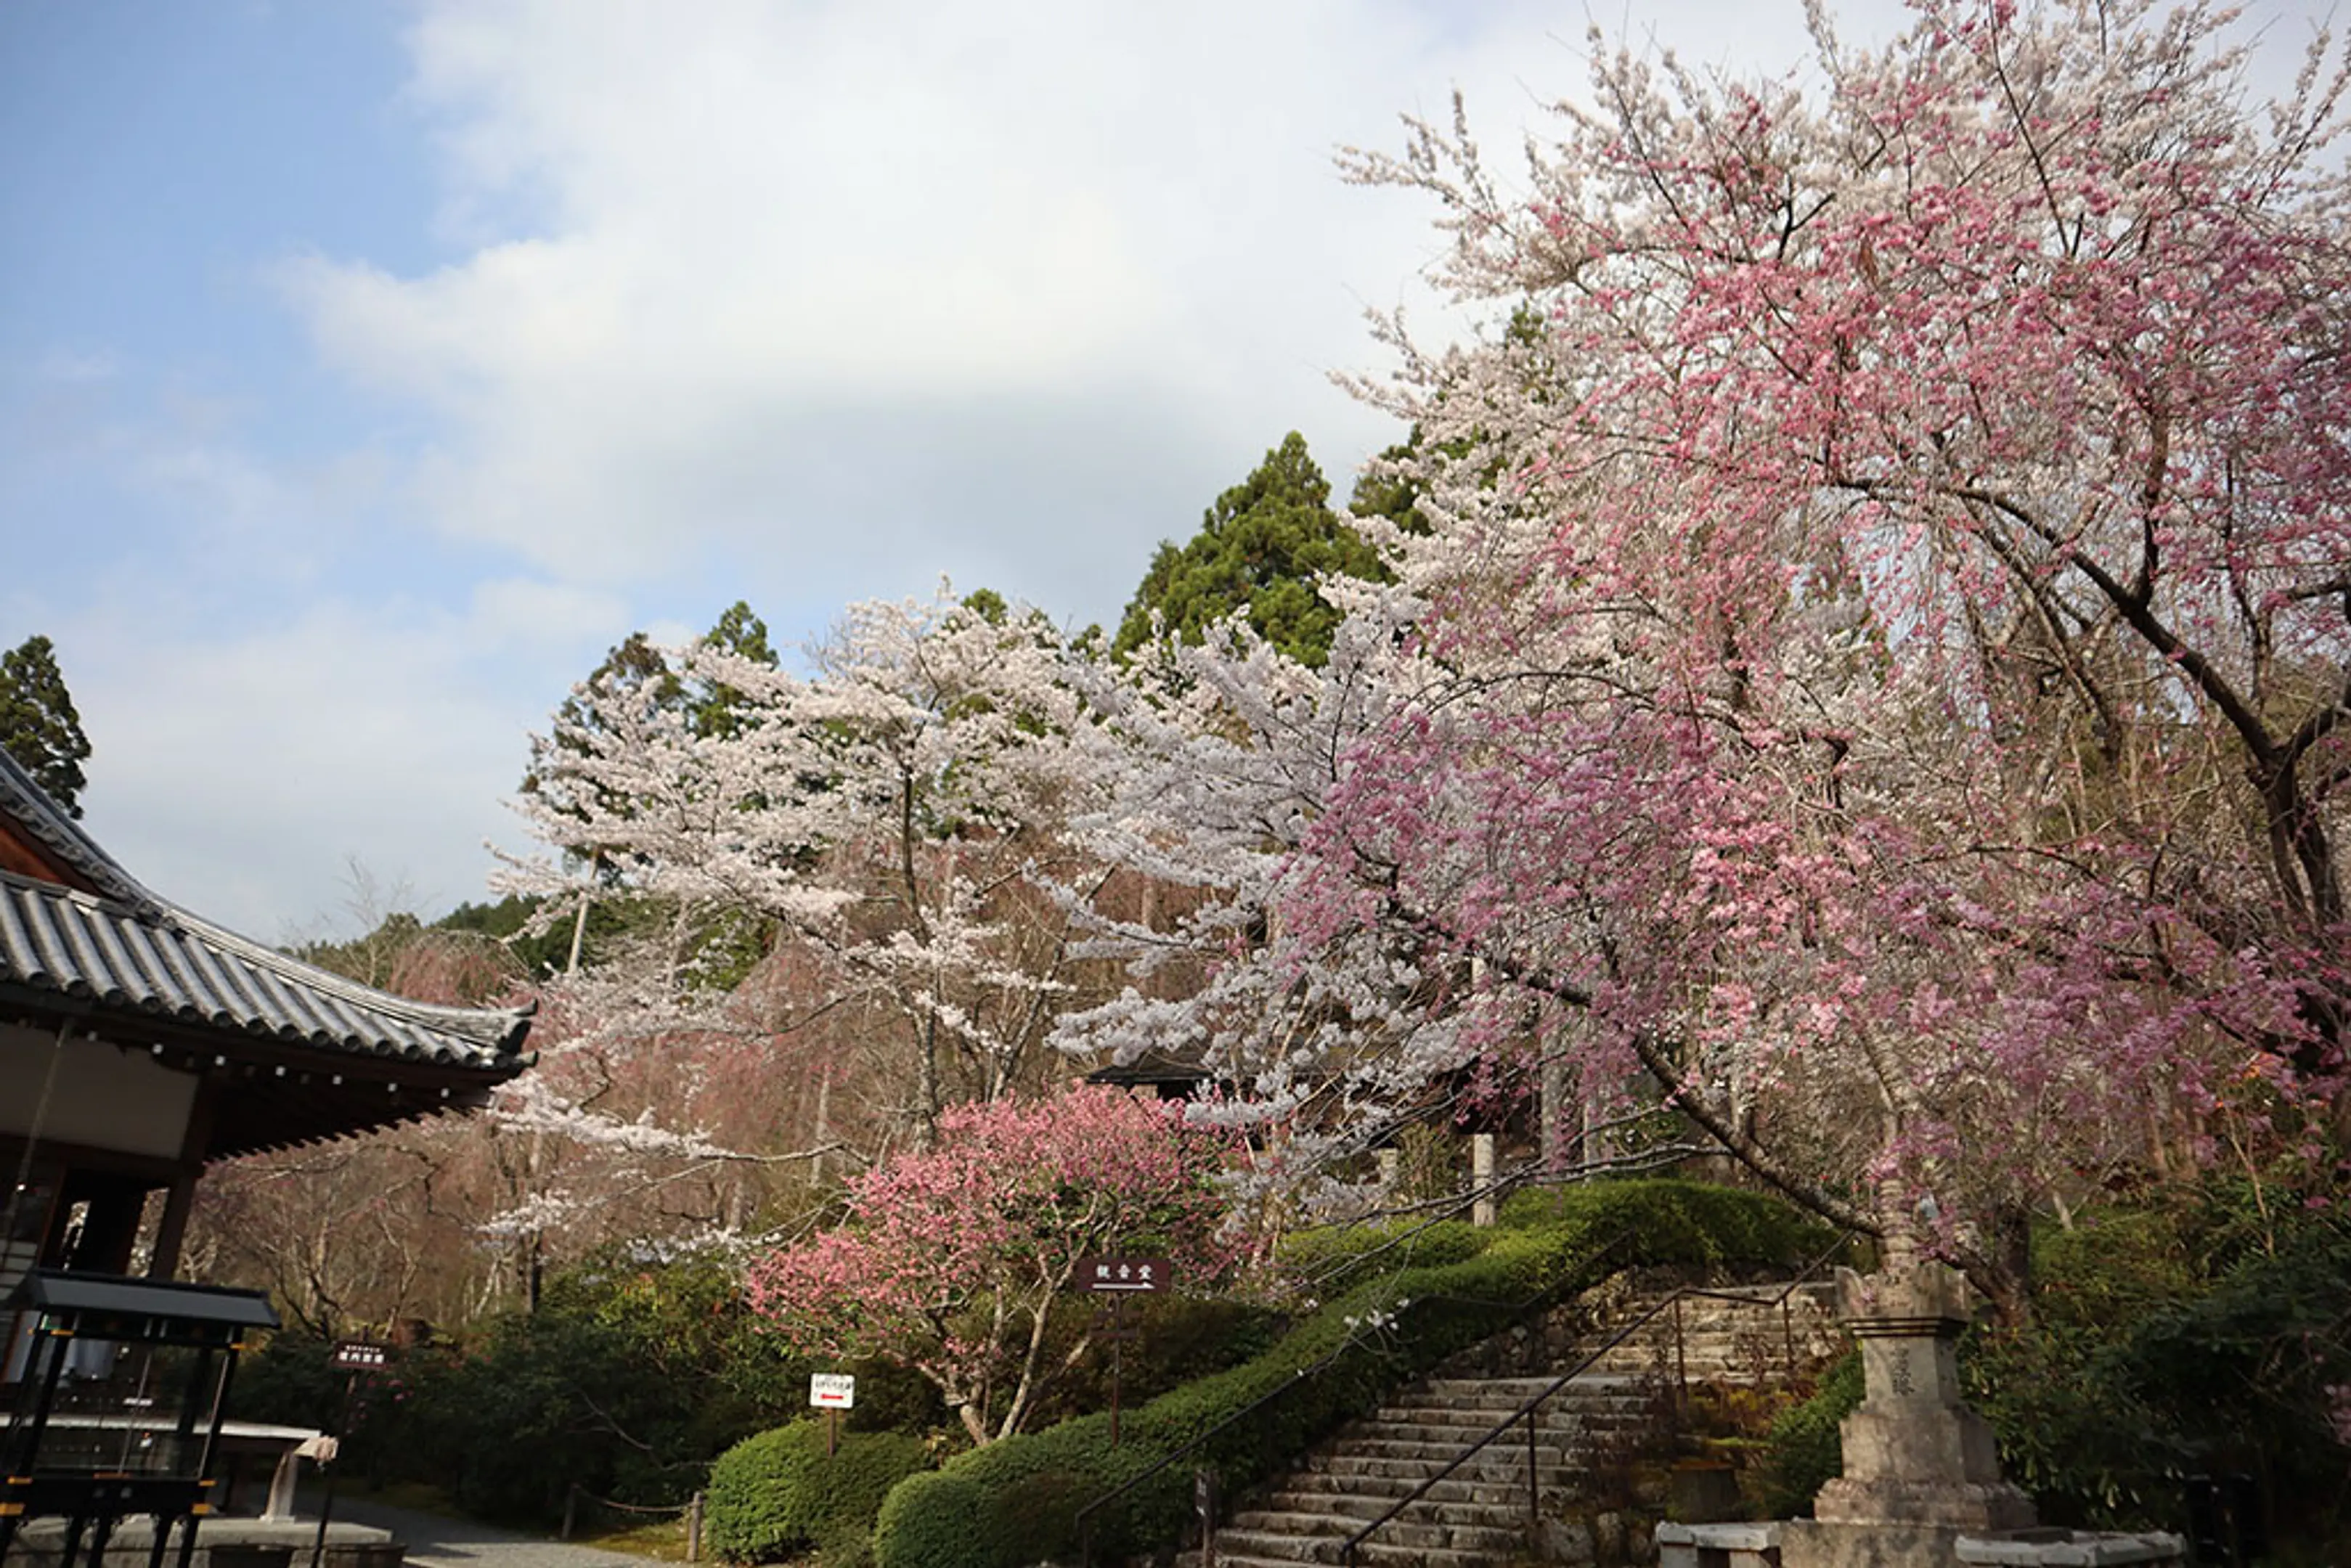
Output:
left=1178, top=1286, right=1836, bottom=1568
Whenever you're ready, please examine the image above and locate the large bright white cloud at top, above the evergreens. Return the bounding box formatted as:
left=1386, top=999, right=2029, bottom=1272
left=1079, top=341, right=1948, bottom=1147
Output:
left=287, top=0, right=1608, bottom=613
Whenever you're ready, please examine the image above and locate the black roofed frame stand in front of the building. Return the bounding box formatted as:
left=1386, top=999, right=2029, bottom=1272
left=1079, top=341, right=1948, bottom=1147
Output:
left=0, top=1270, right=277, bottom=1568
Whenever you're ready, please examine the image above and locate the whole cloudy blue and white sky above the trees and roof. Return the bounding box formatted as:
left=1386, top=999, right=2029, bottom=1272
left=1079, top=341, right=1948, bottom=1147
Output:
left=0, top=0, right=2318, bottom=940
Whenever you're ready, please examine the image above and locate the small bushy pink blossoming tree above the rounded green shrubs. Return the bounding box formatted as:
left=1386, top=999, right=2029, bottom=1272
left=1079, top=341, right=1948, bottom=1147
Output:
left=750, top=1086, right=1225, bottom=1443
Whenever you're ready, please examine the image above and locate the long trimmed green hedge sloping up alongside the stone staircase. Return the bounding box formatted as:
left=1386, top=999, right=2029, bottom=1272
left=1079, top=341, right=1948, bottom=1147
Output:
left=875, top=1180, right=1829, bottom=1568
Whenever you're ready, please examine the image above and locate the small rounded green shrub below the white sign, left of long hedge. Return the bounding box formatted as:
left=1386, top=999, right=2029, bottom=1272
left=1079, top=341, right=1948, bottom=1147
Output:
left=703, top=1420, right=931, bottom=1564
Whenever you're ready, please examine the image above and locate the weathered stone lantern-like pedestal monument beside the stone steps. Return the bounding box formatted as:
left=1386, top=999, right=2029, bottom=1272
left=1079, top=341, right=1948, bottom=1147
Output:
left=1782, top=1249, right=2034, bottom=1568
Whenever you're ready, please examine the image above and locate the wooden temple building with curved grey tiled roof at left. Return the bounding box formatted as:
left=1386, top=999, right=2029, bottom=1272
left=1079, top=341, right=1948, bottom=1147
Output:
left=0, top=752, right=531, bottom=1382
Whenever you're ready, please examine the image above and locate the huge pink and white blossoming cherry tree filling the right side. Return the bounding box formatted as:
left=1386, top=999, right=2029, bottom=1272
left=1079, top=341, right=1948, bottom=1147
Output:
left=1286, top=0, right=2351, bottom=1279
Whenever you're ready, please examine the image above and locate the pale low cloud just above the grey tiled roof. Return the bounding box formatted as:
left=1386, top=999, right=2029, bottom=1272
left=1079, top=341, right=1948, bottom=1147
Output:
left=61, top=595, right=597, bottom=940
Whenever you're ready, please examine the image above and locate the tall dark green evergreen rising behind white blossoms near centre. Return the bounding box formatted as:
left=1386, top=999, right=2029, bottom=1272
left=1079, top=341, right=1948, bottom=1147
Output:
left=1112, top=430, right=1387, bottom=665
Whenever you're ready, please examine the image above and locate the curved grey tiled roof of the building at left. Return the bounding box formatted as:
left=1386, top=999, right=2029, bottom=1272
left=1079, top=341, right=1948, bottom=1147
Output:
left=0, top=752, right=531, bottom=1072
